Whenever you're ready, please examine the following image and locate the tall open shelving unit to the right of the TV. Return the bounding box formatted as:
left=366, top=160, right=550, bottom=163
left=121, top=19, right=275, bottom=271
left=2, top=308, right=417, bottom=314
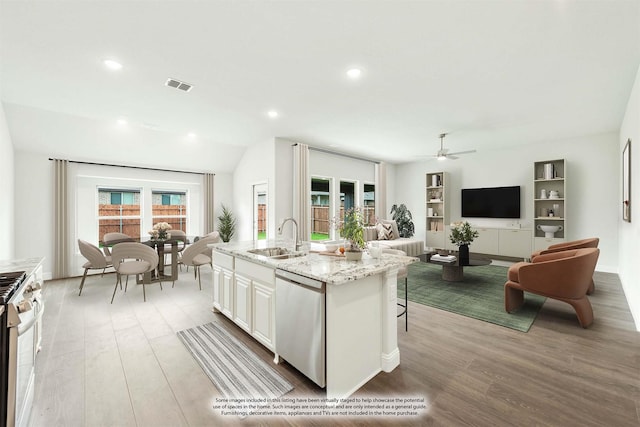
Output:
left=533, top=159, right=567, bottom=251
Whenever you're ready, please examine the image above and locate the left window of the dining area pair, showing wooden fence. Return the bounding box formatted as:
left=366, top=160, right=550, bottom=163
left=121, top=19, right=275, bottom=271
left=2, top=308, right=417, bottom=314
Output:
left=97, top=188, right=140, bottom=241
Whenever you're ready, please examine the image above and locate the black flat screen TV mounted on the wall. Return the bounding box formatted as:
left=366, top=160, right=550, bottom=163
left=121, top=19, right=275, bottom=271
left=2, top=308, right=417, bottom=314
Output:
left=462, top=186, right=520, bottom=218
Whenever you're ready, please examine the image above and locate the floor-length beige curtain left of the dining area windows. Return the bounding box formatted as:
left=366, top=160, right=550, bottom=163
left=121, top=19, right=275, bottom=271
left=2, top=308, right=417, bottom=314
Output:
left=53, top=159, right=70, bottom=279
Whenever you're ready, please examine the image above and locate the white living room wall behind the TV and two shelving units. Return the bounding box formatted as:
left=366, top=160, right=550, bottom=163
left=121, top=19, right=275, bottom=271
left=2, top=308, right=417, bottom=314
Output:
left=391, top=134, right=620, bottom=272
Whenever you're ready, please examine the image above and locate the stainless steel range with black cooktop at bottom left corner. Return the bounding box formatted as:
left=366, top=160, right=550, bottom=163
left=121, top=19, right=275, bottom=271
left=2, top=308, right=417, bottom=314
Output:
left=0, top=271, right=44, bottom=427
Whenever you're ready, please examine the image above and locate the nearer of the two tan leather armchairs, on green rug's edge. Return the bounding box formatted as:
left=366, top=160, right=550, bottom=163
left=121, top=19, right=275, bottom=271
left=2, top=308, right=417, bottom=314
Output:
left=504, top=248, right=600, bottom=328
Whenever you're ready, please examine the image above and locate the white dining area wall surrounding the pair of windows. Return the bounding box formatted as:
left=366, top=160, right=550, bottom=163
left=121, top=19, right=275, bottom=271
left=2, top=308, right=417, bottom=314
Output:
left=15, top=150, right=232, bottom=279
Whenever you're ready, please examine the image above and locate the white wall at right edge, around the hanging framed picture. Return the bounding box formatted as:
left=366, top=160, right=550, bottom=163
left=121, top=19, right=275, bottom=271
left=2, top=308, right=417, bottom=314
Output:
left=616, top=63, right=640, bottom=331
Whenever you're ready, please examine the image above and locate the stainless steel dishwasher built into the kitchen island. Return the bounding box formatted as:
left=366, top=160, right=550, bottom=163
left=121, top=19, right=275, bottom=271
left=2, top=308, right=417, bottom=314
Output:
left=276, top=269, right=326, bottom=387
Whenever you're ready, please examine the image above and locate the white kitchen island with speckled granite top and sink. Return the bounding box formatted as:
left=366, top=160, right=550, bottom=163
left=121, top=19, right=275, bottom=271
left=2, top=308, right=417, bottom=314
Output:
left=210, top=241, right=417, bottom=401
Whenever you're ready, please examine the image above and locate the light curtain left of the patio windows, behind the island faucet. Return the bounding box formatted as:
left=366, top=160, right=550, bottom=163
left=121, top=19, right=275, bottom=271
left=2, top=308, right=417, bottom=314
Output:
left=293, top=143, right=311, bottom=240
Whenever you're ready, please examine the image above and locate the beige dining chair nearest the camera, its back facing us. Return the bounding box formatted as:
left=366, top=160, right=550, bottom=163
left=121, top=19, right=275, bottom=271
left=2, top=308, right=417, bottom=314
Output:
left=111, top=242, right=162, bottom=304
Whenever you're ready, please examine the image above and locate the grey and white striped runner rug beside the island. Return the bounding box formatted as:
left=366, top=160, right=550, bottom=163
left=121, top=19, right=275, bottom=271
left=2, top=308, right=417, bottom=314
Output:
left=178, top=322, right=293, bottom=399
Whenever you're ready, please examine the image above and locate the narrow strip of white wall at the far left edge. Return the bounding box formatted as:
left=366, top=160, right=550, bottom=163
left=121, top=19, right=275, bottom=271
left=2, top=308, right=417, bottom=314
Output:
left=0, top=103, right=15, bottom=260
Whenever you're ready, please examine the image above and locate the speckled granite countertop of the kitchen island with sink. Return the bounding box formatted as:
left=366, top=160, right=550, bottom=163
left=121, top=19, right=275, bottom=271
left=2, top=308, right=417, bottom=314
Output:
left=209, top=240, right=418, bottom=285
